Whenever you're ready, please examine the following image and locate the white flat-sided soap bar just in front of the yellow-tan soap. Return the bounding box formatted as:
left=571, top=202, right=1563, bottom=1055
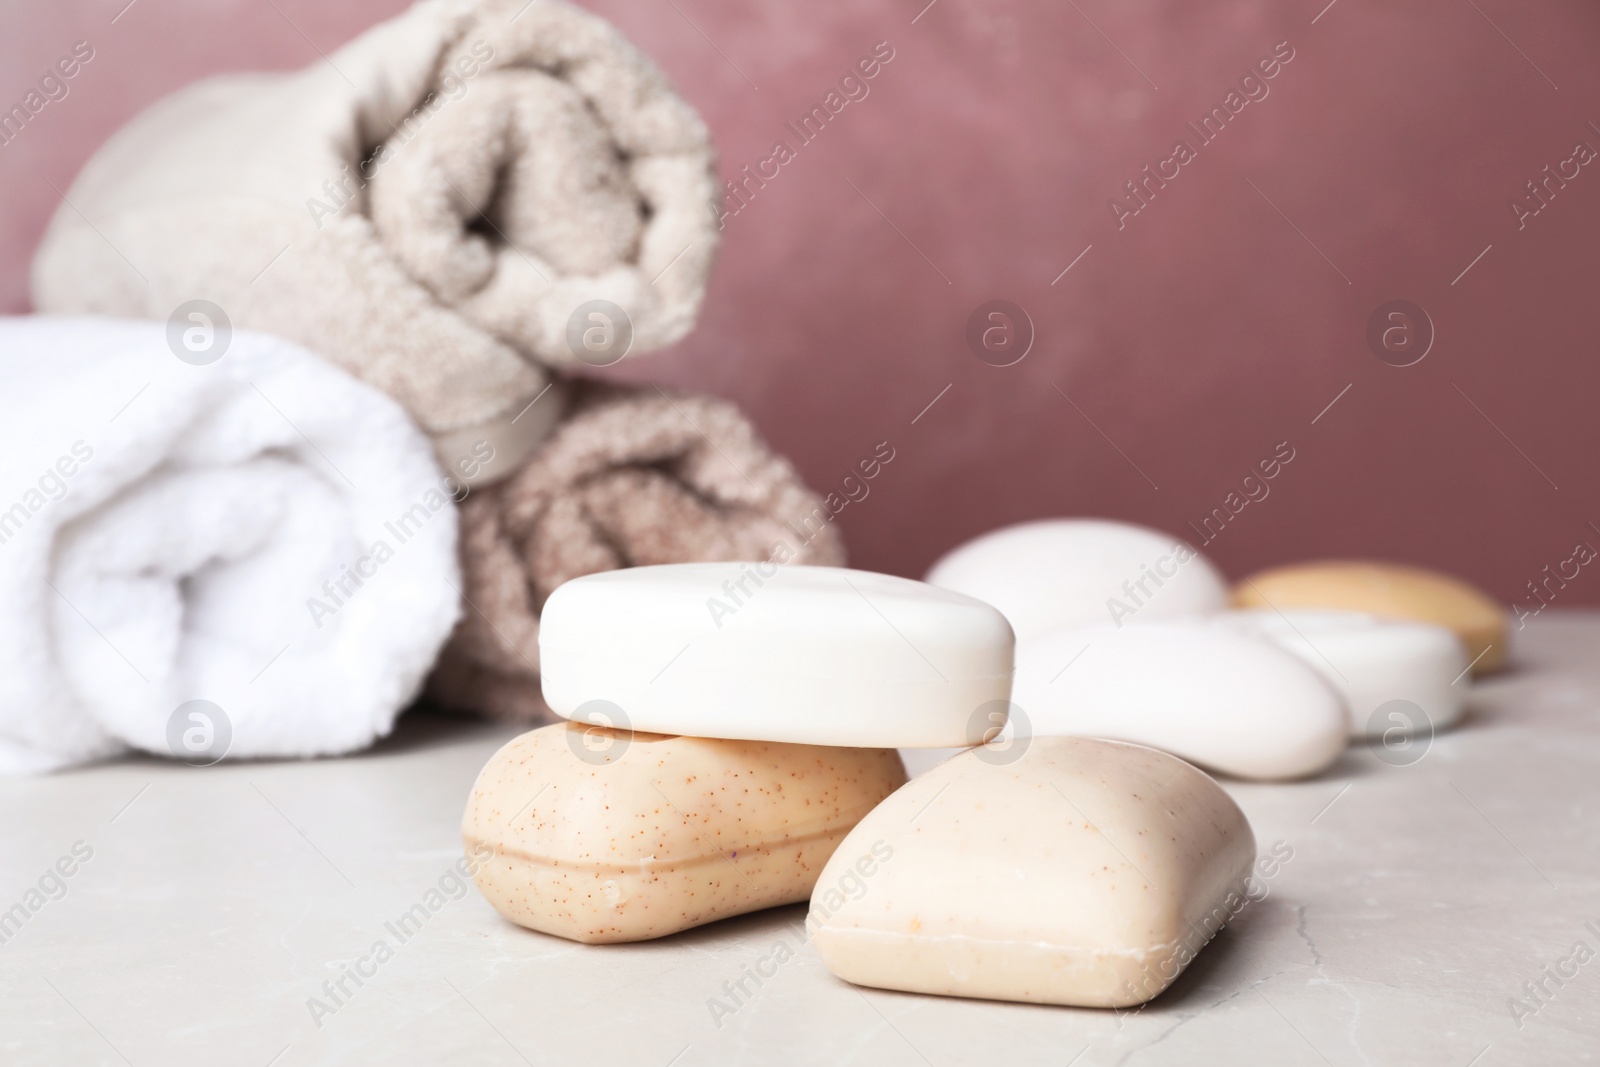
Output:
left=1214, top=608, right=1470, bottom=737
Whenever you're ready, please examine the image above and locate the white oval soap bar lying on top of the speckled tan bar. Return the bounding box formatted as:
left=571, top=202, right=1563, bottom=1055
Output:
left=539, top=563, right=1014, bottom=749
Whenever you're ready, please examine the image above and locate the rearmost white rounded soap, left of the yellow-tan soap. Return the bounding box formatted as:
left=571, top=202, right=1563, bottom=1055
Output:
left=928, top=518, right=1227, bottom=641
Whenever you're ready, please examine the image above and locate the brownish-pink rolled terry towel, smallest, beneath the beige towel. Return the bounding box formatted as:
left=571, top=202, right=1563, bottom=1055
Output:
left=427, top=381, right=845, bottom=721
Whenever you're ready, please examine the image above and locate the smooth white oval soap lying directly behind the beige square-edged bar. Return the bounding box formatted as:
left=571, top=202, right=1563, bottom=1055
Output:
left=1008, top=619, right=1349, bottom=779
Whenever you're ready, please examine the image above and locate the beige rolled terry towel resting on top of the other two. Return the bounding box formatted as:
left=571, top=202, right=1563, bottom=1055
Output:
left=34, top=0, right=717, bottom=480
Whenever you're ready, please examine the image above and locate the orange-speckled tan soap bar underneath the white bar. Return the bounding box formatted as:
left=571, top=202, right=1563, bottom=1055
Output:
left=461, top=723, right=906, bottom=944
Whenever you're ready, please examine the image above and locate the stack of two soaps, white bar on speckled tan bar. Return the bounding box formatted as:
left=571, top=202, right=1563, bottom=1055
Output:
left=462, top=561, right=1014, bottom=942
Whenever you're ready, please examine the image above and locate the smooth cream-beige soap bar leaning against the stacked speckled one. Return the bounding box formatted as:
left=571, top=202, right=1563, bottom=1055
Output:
left=806, top=737, right=1256, bottom=1008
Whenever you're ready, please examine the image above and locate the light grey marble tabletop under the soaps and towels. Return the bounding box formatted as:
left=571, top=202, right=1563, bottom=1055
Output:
left=0, top=611, right=1600, bottom=1067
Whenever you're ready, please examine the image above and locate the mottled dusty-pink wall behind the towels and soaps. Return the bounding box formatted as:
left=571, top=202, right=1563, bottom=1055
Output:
left=0, top=0, right=1600, bottom=603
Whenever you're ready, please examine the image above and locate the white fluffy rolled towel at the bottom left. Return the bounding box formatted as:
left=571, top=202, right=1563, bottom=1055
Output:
left=0, top=316, right=461, bottom=773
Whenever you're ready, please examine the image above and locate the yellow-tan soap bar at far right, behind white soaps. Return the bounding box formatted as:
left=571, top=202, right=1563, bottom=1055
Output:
left=1234, top=560, right=1509, bottom=675
